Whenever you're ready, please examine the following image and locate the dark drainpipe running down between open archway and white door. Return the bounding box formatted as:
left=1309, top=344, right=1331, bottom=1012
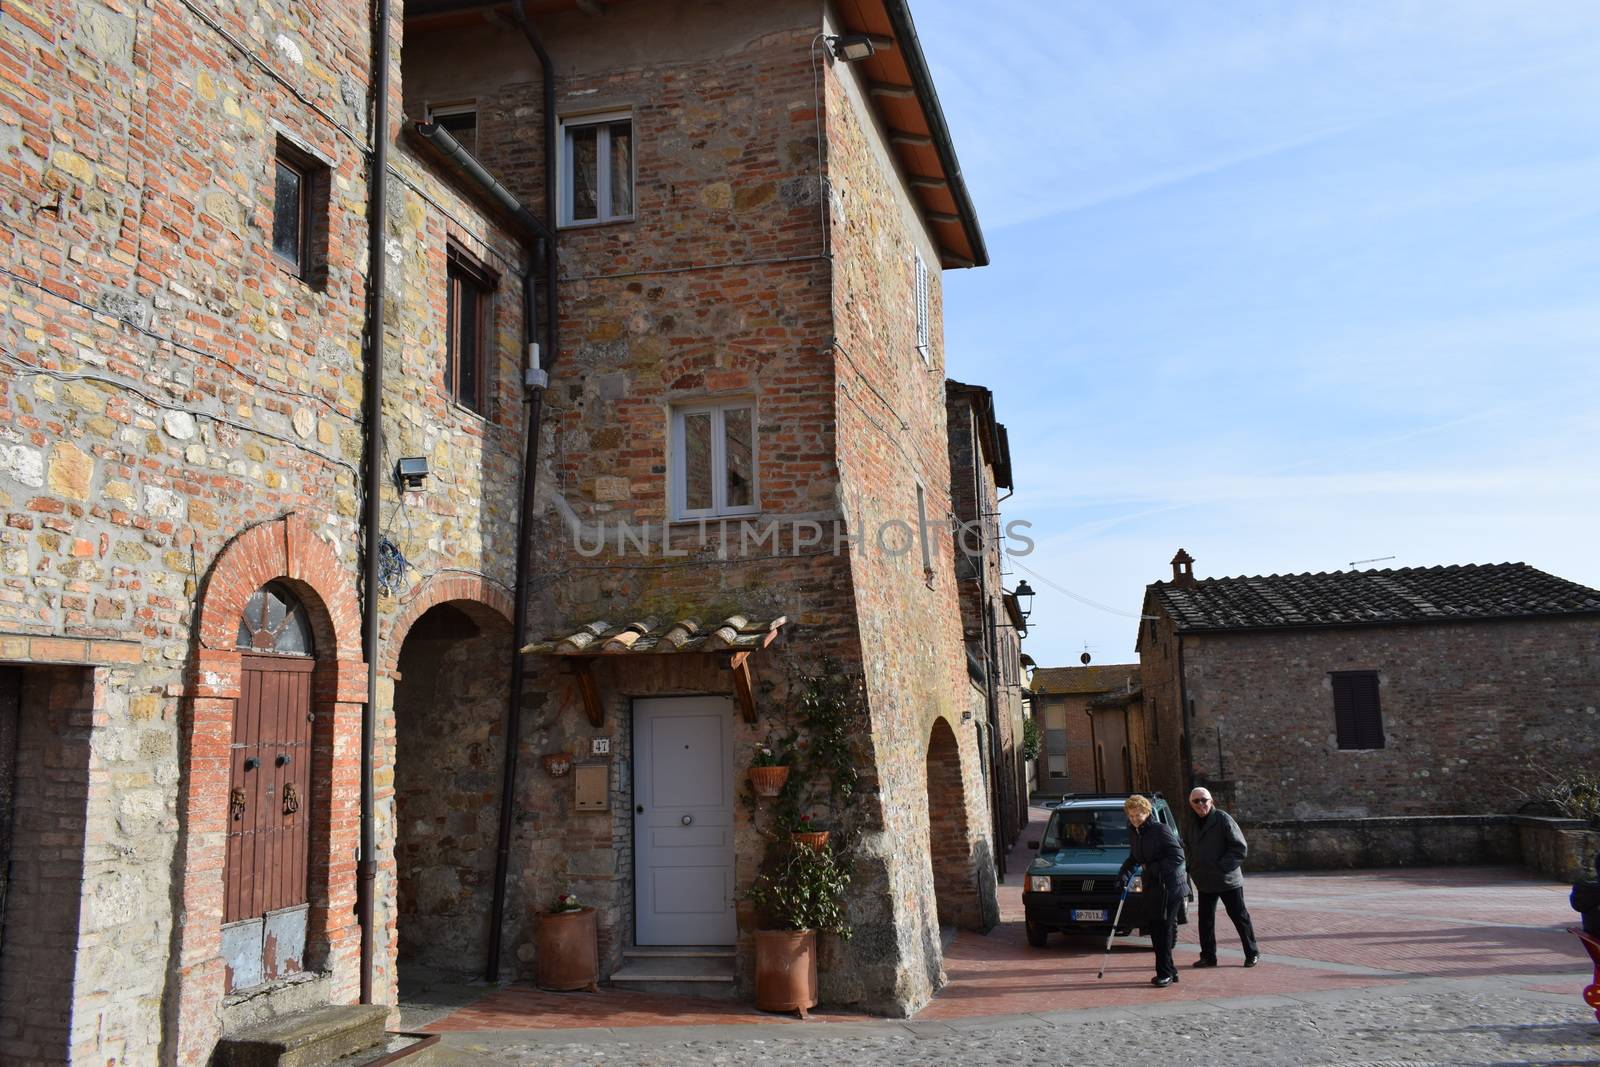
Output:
left=485, top=0, right=560, bottom=982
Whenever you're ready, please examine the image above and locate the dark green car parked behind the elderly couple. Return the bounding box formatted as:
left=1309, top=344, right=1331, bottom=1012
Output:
left=1022, top=793, right=1178, bottom=949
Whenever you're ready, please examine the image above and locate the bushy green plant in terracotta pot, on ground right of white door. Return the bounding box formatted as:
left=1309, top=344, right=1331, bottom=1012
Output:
left=746, top=843, right=850, bottom=1019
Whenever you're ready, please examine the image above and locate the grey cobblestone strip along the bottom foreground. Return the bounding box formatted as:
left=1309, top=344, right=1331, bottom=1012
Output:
left=425, top=979, right=1600, bottom=1067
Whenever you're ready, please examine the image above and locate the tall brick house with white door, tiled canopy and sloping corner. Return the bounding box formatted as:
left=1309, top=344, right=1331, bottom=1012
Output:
left=402, top=0, right=997, bottom=1014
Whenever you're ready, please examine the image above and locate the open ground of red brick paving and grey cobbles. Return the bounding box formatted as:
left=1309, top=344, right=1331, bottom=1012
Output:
left=413, top=808, right=1600, bottom=1064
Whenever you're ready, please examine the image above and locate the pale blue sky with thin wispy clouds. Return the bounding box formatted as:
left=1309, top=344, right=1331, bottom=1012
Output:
left=914, top=0, right=1600, bottom=664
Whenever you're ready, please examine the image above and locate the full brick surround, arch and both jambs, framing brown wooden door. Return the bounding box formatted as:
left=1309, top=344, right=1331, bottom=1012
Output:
left=170, top=514, right=366, bottom=1064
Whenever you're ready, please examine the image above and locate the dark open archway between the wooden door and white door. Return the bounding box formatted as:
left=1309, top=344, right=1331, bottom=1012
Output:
left=394, top=600, right=512, bottom=984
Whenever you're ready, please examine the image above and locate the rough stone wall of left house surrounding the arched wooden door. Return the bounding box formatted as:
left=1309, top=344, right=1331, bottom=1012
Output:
left=0, top=0, right=523, bottom=1062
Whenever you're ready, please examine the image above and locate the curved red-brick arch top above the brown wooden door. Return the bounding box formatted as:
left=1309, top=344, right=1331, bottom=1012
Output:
left=200, top=514, right=362, bottom=661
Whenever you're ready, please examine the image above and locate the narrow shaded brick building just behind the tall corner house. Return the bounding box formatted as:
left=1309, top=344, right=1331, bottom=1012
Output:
left=944, top=381, right=1032, bottom=873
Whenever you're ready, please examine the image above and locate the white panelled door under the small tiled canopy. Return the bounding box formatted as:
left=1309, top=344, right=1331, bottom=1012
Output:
left=634, top=696, right=734, bottom=945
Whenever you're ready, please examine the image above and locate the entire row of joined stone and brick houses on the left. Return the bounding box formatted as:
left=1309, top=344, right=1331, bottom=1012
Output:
left=0, top=0, right=995, bottom=1064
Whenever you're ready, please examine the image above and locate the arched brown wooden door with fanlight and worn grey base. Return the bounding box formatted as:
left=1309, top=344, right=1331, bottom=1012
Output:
left=222, top=582, right=317, bottom=990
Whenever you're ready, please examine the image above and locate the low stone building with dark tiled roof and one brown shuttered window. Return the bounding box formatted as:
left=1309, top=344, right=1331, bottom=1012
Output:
left=1138, top=550, right=1600, bottom=827
